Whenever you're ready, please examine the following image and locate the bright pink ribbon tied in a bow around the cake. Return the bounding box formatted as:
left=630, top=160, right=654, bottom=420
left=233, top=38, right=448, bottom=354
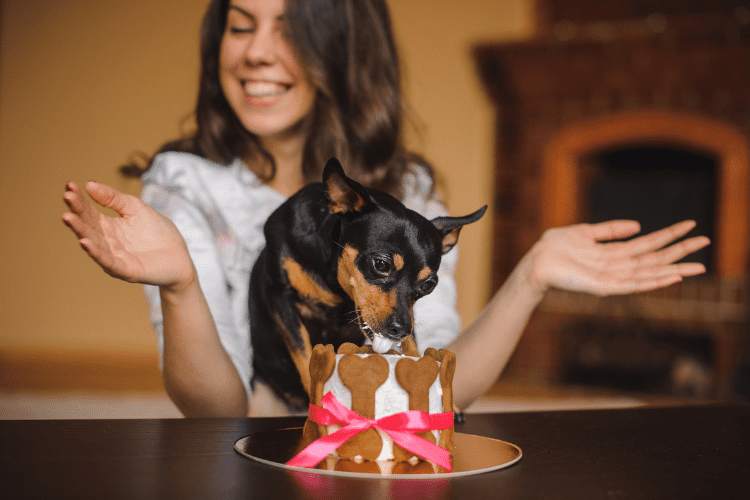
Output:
left=286, top=392, right=453, bottom=472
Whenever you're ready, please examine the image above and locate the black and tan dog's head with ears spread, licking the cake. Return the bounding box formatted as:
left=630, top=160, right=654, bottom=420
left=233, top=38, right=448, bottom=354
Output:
left=323, top=158, right=487, bottom=350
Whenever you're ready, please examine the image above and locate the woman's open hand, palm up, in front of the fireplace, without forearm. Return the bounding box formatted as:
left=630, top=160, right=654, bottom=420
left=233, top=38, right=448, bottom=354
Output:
left=527, top=220, right=710, bottom=296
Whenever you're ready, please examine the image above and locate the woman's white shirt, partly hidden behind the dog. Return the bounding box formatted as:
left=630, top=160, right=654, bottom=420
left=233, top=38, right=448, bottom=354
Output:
left=141, top=152, right=461, bottom=397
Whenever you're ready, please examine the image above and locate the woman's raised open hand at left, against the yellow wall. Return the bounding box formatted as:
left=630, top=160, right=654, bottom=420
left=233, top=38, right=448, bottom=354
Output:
left=62, top=181, right=196, bottom=290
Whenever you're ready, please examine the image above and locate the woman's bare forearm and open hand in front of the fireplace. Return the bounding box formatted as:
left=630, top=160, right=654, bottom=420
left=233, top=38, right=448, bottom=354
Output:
left=448, top=221, right=709, bottom=408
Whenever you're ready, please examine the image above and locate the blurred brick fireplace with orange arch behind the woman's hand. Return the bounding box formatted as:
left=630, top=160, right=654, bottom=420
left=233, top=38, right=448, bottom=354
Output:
left=474, top=0, right=750, bottom=397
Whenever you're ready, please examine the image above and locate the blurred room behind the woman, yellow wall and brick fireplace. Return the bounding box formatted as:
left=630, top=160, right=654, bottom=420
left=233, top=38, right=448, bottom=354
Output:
left=0, top=0, right=750, bottom=418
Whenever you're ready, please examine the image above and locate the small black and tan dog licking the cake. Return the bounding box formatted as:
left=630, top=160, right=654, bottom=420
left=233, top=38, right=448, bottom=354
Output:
left=248, top=158, right=487, bottom=410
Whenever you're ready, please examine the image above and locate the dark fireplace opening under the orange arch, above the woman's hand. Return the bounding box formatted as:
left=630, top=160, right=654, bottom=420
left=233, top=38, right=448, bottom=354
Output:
left=583, top=145, right=718, bottom=273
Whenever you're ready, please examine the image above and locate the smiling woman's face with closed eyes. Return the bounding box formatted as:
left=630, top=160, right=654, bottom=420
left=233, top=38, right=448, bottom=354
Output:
left=219, top=0, right=316, bottom=140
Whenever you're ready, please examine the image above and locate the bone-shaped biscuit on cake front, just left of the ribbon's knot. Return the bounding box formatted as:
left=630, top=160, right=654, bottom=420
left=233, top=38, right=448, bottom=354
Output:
left=338, top=354, right=389, bottom=460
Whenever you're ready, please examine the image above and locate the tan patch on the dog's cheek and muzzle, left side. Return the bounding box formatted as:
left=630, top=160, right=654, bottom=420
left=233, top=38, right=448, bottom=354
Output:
left=338, top=245, right=398, bottom=332
